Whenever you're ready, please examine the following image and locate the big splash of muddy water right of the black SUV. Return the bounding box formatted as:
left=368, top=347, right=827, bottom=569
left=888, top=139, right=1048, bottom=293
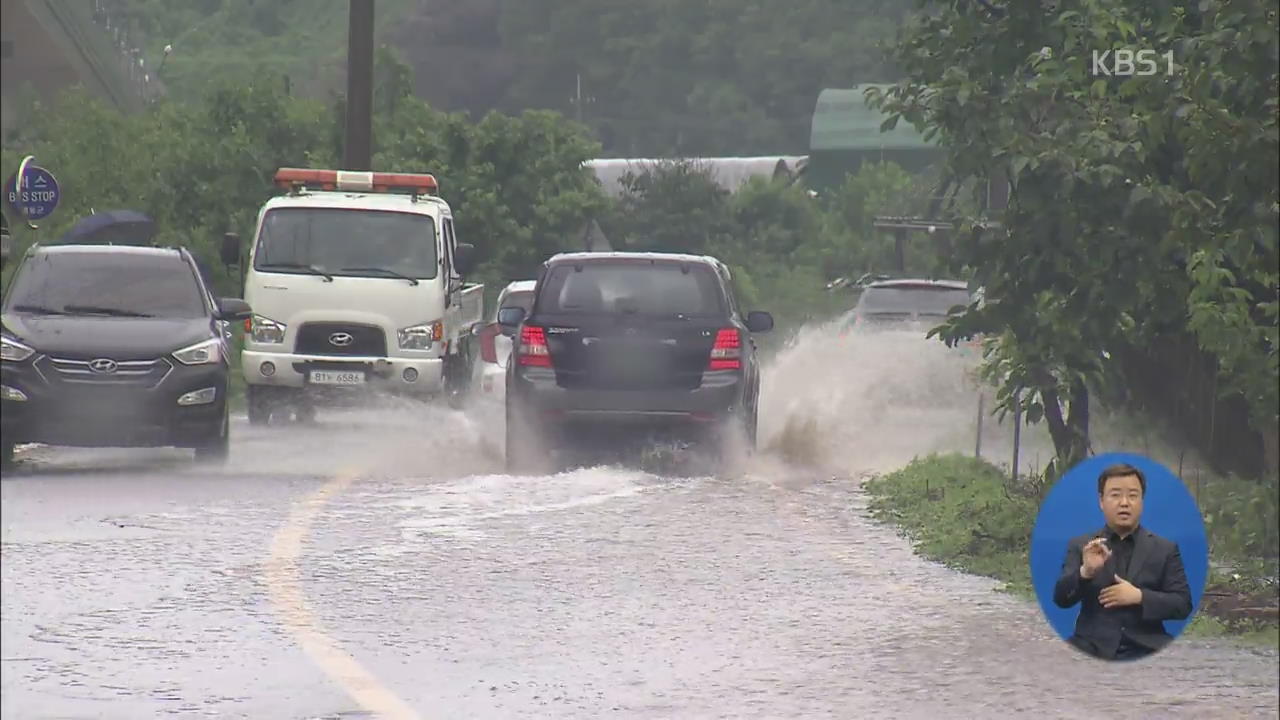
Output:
left=760, top=316, right=1201, bottom=474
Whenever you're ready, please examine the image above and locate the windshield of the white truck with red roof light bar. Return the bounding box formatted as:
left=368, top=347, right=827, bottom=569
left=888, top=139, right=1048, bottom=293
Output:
left=253, top=208, right=438, bottom=279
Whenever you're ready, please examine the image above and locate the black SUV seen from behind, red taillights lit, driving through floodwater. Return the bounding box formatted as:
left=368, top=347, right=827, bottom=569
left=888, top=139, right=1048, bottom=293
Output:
left=498, top=252, right=773, bottom=471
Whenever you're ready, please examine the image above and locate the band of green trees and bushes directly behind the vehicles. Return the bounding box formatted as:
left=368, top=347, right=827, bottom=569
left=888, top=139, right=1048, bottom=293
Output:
left=3, top=63, right=937, bottom=342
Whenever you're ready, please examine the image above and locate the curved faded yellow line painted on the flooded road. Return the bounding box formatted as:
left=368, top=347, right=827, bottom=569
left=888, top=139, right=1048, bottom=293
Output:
left=266, top=473, right=421, bottom=720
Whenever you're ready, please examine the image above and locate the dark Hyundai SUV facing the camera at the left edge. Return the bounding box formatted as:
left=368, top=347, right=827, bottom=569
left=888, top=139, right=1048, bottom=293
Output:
left=0, top=245, right=250, bottom=464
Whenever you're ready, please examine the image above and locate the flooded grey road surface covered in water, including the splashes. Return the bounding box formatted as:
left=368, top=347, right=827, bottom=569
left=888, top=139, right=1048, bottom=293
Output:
left=0, top=326, right=1280, bottom=720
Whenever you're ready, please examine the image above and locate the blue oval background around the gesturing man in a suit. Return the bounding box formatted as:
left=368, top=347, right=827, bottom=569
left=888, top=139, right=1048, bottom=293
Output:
left=1030, top=452, right=1208, bottom=650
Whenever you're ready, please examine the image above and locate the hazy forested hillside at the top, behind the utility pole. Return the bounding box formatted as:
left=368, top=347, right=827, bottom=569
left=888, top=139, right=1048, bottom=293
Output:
left=107, top=0, right=904, bottom=156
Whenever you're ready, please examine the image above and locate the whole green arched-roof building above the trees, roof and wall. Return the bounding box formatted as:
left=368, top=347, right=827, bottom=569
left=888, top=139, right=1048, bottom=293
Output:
left=806, top=85, right=941, bottom=188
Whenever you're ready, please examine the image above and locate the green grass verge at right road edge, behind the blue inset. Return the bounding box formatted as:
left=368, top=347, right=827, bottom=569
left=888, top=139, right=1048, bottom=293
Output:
left=864, top=454, right=1280, bottom=647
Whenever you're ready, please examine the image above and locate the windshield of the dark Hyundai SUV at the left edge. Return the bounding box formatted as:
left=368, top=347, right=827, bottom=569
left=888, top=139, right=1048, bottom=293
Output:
left=5, top=251, right=209, bottom=318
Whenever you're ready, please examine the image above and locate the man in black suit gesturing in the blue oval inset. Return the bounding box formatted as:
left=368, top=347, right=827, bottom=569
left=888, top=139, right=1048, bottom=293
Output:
left=1053, top=464, right=1192, bottom=660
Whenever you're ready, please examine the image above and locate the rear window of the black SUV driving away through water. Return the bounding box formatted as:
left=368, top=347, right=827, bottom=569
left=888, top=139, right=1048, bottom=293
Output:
left=538, top=261, right=724, bottom=316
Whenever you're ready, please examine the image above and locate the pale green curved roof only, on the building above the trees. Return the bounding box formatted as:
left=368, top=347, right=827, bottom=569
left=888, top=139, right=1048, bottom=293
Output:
left=809, top=85, right=937, bottom=152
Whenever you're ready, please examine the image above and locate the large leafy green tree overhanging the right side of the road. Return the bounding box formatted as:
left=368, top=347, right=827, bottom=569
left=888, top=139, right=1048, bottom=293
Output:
left=883, top=0, right=1280, bottom=481
